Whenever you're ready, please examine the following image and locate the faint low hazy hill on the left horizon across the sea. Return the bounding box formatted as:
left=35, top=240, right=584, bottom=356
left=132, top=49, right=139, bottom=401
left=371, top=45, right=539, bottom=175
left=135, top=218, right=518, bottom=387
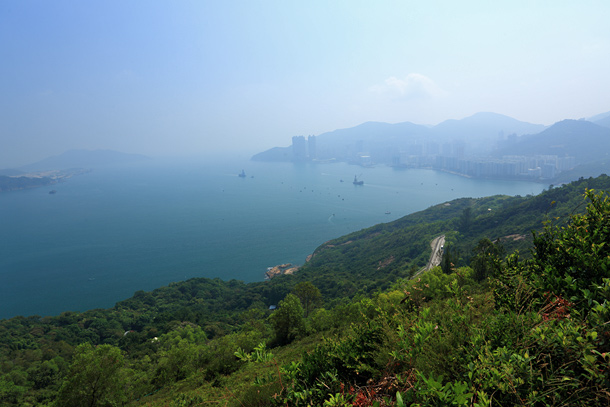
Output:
left=19, top=150, right=148, bottom=171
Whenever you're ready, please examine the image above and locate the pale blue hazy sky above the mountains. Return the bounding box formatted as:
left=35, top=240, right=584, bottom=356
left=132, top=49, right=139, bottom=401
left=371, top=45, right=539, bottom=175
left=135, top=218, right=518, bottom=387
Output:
left=0, top=0, right=610, bottom=168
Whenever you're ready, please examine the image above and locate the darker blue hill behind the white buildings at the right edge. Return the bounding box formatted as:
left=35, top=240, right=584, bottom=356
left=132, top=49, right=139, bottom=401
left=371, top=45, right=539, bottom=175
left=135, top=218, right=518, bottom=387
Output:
left=496, top=120, right=610, bottom=163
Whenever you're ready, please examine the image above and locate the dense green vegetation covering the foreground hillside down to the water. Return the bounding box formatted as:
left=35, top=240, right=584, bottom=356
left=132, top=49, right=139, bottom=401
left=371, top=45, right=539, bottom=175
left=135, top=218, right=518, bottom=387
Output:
left=0, top=176, right=610, bottom=406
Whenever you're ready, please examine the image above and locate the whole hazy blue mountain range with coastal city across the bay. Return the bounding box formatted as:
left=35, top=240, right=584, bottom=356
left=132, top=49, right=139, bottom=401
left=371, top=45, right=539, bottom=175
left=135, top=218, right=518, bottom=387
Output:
left=252, top=112, right=610, bottom=182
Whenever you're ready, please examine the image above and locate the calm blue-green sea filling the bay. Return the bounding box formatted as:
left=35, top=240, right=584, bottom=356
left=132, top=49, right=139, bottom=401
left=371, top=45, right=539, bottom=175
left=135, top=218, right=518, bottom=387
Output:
left=0, top=157, right=545, bottom=318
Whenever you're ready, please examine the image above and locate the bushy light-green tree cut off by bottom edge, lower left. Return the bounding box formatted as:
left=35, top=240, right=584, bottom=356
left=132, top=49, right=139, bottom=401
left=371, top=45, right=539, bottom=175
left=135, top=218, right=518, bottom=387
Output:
left=55, top=343, right=126, bottom=407
